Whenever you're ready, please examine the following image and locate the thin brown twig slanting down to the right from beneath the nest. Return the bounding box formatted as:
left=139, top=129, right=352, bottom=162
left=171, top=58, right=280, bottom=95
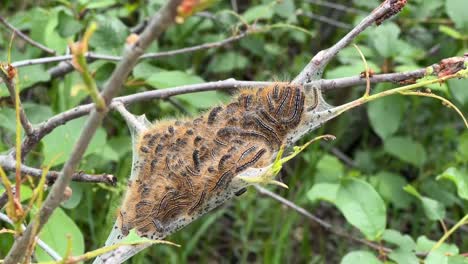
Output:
left=255, top=185, right=392, bottom=253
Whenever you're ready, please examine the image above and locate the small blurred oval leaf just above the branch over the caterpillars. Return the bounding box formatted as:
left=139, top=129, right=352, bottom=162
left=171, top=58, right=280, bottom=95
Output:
left=208, top=51, right=249, bottom=73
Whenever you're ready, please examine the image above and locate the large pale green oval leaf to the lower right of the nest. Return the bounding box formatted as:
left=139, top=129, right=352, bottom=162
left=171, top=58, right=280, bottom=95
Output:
left=336, top=178, right=387, bottom=240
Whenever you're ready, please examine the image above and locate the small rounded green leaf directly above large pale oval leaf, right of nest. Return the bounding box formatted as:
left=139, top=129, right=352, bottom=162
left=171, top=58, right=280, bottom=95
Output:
left=315, top=154, right=344, bottom=182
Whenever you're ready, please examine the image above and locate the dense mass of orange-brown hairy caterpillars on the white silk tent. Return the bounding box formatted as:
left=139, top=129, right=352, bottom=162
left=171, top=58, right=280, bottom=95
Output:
left=118, top=83, right=317, bottom=239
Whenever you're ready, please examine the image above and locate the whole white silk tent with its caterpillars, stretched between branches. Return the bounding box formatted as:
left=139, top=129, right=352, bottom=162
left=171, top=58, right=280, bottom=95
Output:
left=94, top=83, right=354, bottom=264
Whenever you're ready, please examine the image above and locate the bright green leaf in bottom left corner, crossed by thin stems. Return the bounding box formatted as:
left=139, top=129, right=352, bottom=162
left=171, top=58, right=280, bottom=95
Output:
left=36, top=208, right=84, bottom=261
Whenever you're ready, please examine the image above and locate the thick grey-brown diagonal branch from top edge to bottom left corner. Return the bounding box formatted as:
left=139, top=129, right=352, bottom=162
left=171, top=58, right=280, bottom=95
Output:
left=4, top=0, right=181, bottom=264
